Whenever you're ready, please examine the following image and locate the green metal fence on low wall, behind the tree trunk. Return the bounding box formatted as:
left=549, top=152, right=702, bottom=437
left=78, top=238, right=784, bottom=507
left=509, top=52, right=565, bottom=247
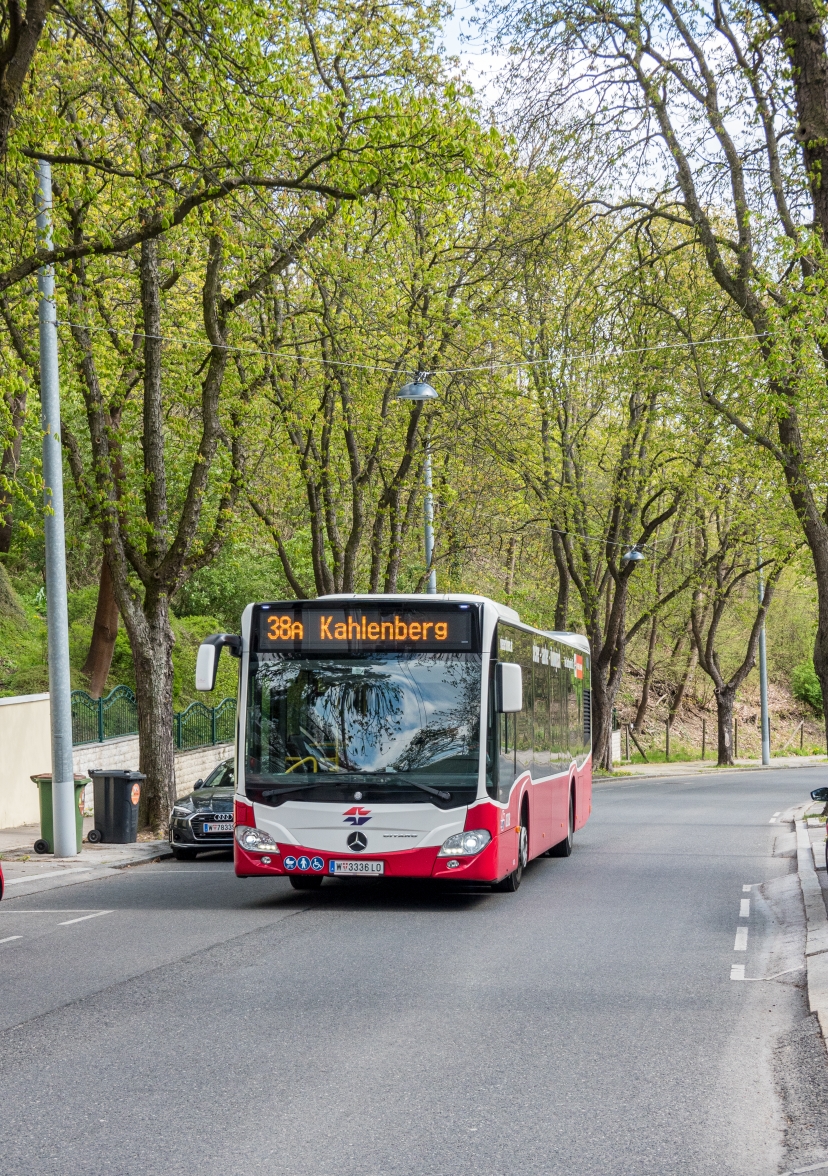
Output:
left=72, top=686, right=235, bottom=751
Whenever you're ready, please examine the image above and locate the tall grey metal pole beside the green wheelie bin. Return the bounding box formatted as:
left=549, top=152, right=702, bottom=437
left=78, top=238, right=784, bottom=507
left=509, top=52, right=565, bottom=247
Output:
left=36, top=159, right=78, bottom=857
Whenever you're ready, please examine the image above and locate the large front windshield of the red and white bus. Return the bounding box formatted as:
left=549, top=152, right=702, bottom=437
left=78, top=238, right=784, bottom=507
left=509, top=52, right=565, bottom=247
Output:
left=246, top=650, right=482, bottom=801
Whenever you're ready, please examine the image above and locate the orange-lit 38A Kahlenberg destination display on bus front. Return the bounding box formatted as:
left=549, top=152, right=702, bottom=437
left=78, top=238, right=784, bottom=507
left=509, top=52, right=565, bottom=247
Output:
left=259, top=606, right=475, bottom=653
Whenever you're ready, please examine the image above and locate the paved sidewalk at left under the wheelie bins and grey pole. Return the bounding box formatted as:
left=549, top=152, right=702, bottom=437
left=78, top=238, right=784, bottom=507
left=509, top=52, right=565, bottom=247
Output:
left=0, top=817, right=172, bottom=902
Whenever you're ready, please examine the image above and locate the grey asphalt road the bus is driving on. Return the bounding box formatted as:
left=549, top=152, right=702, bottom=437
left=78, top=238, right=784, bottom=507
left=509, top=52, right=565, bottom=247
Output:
left=0, top=769, right=828, bottom=1176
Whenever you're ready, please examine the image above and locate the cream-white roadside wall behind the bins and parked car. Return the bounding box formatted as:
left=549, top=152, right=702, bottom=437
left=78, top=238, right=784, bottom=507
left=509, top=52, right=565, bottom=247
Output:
left=0, top=694, right=233, bottom=829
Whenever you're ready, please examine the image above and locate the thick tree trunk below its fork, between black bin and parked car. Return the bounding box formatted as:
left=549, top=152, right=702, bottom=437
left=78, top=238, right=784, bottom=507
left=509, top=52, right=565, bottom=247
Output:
left=122, top=594, right=175, bottom=836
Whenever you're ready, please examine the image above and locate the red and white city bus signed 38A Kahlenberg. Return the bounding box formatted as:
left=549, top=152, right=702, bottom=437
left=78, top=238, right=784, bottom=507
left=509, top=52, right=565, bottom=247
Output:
left=196, top=594, right=592, bottom=890
